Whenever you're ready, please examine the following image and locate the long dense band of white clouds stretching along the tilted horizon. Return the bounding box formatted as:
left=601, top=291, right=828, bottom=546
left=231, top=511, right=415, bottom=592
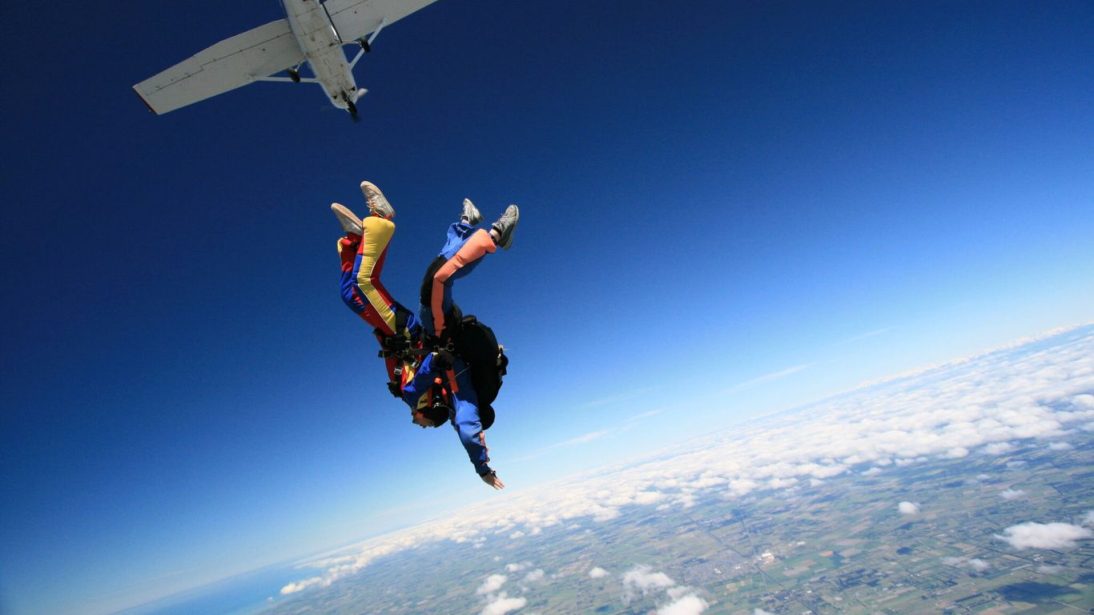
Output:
left=283, top=326, right=1094, bottom=592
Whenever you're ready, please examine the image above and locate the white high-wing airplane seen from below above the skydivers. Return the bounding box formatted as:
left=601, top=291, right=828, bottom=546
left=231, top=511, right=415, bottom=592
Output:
left=133, top=0, right=437, bottom=120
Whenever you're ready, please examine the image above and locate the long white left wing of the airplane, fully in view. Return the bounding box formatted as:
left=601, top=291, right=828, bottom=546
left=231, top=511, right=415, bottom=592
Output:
left=133, top=18, right=308, bottom=115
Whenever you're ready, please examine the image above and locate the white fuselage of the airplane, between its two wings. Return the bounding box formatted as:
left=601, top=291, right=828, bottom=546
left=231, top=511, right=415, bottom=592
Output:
left=281, top=0, right=363, bottom=109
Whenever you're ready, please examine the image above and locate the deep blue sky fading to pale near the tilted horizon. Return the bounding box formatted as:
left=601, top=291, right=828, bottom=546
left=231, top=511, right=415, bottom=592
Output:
left=0, top=0, right=1094, bottom=613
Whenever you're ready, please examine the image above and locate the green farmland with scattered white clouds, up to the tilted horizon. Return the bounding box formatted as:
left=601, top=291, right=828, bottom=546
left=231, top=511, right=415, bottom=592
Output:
left=258, top=326, right=1094, bottom=615
